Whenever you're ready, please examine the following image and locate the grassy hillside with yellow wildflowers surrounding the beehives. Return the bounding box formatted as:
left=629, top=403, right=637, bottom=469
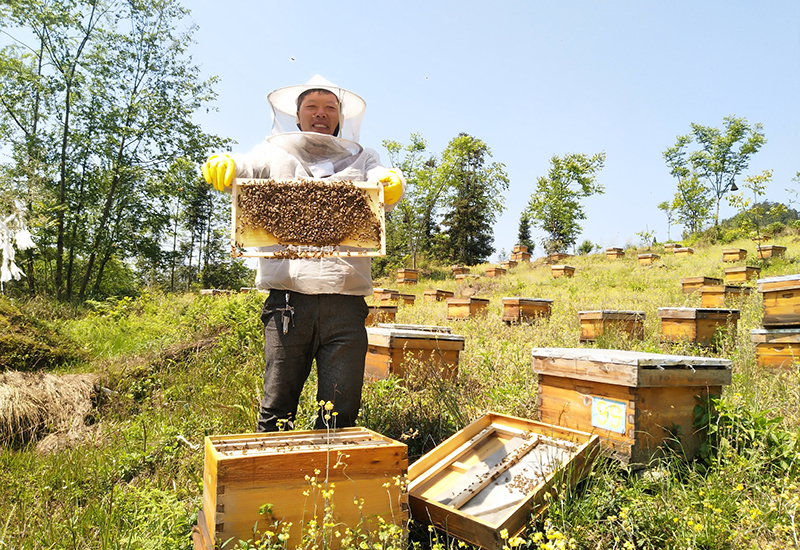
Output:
left=0, top=237, right=800, bottom=549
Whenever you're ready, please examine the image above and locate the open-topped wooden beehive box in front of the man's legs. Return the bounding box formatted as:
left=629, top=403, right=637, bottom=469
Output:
left=198, top=427, right=408, bottom=550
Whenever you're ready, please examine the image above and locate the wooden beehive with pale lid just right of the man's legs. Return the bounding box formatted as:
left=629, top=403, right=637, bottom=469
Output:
left=364, top=325, right=464, bottom=380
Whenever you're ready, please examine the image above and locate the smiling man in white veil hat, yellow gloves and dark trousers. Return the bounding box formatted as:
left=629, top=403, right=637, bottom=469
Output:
left=203, top=76, right=405, bottom=432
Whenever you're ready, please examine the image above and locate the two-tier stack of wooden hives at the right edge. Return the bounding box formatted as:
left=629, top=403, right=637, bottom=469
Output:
left=750, top=274, right=800, bottom=368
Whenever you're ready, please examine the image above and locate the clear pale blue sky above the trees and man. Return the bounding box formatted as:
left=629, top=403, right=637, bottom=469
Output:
left=186, top=0, right=800, bottom=259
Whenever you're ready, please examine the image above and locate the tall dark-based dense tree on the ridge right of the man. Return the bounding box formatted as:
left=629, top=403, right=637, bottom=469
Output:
left=434, top=133, right=508, bottom=265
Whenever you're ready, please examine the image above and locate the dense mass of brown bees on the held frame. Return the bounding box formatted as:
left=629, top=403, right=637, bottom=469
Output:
left=237, top=180, right=381, bottom=247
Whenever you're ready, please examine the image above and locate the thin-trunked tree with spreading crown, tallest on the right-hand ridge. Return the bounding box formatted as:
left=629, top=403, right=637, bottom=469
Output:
left=664, top=115, right=767, bottom=227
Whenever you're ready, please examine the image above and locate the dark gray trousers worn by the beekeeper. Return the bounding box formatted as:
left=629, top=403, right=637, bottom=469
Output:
left=257, top=290, right=369, bottom=432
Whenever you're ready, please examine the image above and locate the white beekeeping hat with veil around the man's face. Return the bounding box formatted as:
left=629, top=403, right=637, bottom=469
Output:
left=267, top=75, right=367, bottom=142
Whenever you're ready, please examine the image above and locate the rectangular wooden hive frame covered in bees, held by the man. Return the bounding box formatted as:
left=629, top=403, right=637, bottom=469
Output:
left=231, top=179, right=386, bottom=258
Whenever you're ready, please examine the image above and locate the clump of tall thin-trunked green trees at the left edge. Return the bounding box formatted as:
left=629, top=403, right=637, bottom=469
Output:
left=0, top=0, right=224, bottom=299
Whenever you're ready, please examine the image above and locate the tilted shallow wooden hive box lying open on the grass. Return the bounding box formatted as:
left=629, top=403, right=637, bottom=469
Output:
left=408, top=413, right=599, bottom=550
